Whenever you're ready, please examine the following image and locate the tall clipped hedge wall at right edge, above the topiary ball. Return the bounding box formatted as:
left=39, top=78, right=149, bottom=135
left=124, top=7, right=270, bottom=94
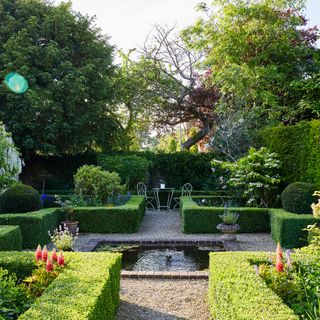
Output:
left=260, top=120, right=320, bottom=188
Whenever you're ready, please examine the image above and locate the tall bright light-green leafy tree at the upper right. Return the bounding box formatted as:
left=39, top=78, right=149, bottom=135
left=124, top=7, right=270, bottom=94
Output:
left=183, top=0, right=320, bottom=123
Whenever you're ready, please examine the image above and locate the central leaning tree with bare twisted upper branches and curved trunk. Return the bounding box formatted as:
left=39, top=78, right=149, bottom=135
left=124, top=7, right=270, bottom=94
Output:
left=117, top=26, right=220, bottom=149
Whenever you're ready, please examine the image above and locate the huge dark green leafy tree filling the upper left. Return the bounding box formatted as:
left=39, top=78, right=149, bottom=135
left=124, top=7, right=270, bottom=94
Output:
left=0, top=0, right=119, bottom=155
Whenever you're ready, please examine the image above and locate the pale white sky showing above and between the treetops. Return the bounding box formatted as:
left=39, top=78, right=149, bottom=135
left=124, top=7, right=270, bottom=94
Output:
left=54, top=0, right=320, bottom=50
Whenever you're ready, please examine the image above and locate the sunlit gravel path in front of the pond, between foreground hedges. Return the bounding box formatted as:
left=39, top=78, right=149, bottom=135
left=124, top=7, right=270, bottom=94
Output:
left=117, top=279, right=211, bottom=320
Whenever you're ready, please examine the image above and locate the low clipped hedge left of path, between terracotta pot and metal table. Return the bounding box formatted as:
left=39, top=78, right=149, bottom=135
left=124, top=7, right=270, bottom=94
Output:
left=65, top=196, right=145, bottom=233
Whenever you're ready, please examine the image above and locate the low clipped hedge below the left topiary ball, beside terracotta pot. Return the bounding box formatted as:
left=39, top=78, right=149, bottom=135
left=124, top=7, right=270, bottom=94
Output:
left=0, top=209, right=59, bottom=248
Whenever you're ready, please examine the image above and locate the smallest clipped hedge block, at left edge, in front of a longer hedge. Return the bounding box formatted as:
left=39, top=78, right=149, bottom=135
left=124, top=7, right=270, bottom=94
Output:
left=0, top=226, right=22, bottom=251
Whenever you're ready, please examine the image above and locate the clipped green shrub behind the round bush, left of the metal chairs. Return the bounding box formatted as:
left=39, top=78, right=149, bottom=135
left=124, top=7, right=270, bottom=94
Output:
left=98, top=154, right=150, bottom=190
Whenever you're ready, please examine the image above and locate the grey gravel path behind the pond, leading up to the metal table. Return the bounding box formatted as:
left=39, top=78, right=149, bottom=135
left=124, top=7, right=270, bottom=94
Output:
left=75, top=211, right=276, bottom=251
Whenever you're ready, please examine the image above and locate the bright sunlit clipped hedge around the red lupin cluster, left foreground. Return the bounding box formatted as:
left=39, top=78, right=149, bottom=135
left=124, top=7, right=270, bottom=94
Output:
left=0, top=252, right=121, bottom=320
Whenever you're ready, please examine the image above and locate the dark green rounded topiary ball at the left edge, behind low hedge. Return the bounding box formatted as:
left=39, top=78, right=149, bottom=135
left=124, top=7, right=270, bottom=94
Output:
left=0, top=184, right=41, bottom=213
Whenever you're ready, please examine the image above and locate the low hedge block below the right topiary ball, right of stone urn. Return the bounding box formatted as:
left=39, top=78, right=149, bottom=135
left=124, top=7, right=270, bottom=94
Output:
left=270, top=209, right=317, bottom=248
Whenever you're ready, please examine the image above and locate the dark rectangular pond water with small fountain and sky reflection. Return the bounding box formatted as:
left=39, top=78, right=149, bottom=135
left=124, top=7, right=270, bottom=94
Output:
left=97, top=246, right=225, bottom=271
